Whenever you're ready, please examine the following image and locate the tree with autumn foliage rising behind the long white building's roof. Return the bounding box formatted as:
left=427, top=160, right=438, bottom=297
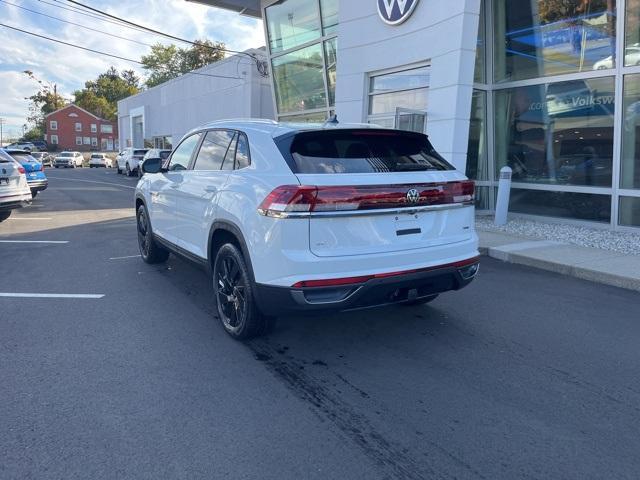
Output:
left=141, top=40, right=225, bottom=87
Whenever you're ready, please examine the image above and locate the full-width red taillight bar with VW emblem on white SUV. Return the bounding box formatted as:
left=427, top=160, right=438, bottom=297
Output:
left=258, top=180, right=475, bottom=217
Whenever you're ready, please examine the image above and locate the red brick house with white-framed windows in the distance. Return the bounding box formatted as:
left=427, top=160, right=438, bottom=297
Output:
left=44, top=104, right=118, bottom=152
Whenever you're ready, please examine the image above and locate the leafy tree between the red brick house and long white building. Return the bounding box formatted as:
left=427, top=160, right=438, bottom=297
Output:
left=73, top=67, right=140, bottom=121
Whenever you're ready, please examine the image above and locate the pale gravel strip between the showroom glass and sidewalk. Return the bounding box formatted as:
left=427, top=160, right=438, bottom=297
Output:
left=476, top=216, right=640, bottom=255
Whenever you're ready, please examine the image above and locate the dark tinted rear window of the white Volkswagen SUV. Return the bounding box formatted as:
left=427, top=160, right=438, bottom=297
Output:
left=276, top=129, right=454, bottom=174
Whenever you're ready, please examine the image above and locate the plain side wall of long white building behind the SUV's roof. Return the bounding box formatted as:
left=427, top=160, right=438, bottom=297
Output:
left=118, top=50, right=275, bottom=148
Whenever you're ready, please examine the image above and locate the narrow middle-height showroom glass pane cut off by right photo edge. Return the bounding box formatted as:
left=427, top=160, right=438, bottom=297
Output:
left=620, top=74, right=640, bottom=188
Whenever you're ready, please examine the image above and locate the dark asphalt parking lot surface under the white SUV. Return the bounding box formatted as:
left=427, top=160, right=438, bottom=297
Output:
left=0, top=169, right=640, bottom=479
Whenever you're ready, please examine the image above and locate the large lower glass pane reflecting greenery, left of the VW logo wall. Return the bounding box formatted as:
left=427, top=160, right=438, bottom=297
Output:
left=273, top=44, right=327, bottom=113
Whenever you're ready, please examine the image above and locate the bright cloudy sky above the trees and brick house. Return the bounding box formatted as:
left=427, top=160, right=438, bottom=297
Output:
left=0, top=0, right=265, bottom=139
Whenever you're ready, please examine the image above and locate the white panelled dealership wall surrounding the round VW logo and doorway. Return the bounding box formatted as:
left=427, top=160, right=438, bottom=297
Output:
left=336, top=0, right=480, bottom=171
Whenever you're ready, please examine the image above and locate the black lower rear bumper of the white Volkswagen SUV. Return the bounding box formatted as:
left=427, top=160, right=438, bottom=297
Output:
left=255, top=257, right=479, bottom=315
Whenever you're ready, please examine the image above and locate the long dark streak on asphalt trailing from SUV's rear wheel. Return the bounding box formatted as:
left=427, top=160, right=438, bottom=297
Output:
left=248, top=339, right=446, bottom=480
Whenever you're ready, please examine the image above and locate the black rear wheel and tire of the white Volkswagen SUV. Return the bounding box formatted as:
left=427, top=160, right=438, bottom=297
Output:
left=213, top=243, right=268, bottom=340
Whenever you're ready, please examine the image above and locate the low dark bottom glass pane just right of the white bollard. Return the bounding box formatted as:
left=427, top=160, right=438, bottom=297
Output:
left=509, top=188, right=611, bottom=222
